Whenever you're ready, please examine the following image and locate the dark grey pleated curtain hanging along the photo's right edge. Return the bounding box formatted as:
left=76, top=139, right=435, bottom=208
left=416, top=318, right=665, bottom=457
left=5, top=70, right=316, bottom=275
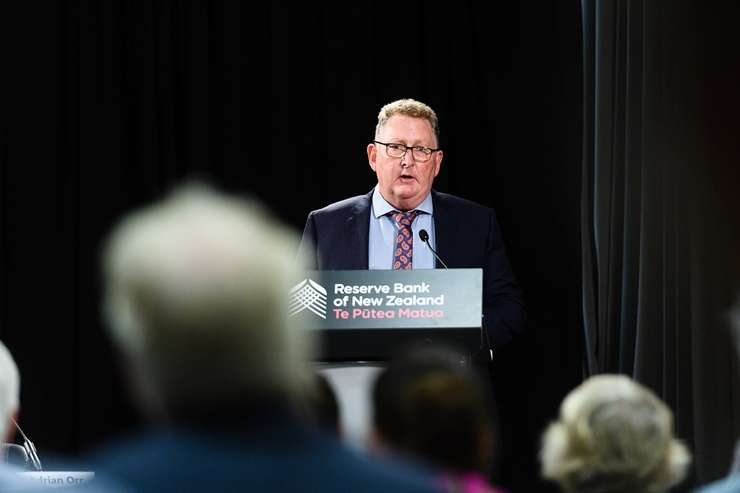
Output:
left=582, top=0, right=740, bottom=491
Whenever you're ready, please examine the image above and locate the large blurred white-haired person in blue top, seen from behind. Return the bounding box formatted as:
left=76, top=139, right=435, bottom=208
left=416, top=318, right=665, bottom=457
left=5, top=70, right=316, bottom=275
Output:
left=91, top=187, right=442, bottom=493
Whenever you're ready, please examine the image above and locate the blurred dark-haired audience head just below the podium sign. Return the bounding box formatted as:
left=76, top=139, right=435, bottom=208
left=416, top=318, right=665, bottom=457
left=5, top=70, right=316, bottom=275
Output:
left=372, top=346, right=493, bottom=473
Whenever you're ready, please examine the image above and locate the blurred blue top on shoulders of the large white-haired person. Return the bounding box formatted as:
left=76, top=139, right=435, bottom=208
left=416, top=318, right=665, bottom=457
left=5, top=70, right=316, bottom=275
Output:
left=84, top=413, right=437, bottom=493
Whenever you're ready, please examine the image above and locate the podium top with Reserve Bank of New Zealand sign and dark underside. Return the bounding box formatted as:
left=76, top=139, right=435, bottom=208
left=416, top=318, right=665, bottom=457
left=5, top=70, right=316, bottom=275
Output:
left=290, top=269, right=483, bottom=362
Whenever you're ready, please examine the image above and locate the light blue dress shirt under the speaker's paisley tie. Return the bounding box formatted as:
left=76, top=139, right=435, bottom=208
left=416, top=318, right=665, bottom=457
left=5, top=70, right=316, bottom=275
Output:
left=368, top=186, right=437, bottom=270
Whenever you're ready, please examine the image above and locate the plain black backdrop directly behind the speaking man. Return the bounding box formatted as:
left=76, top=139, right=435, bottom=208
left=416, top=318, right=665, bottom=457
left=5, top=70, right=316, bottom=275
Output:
left=0, top=0, right=582, bottom=491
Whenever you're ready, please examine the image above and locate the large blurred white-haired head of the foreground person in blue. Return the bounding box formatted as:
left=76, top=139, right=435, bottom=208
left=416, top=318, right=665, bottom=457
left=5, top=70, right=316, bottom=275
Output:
left=104, top=185, right=312, bottom=409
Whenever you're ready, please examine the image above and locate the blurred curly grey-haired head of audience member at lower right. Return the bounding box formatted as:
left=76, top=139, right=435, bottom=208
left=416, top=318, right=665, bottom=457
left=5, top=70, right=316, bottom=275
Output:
left=540, top=375, right=691, bottom=493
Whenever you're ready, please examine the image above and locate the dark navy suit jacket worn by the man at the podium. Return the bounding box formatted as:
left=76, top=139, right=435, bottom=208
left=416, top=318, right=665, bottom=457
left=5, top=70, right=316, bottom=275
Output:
left=301, top=190, right=526, bottom=348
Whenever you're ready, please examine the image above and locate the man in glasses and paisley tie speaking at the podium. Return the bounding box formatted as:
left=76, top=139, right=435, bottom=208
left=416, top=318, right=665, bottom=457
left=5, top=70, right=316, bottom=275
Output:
left=301, top=99, right=526, bottom=347
